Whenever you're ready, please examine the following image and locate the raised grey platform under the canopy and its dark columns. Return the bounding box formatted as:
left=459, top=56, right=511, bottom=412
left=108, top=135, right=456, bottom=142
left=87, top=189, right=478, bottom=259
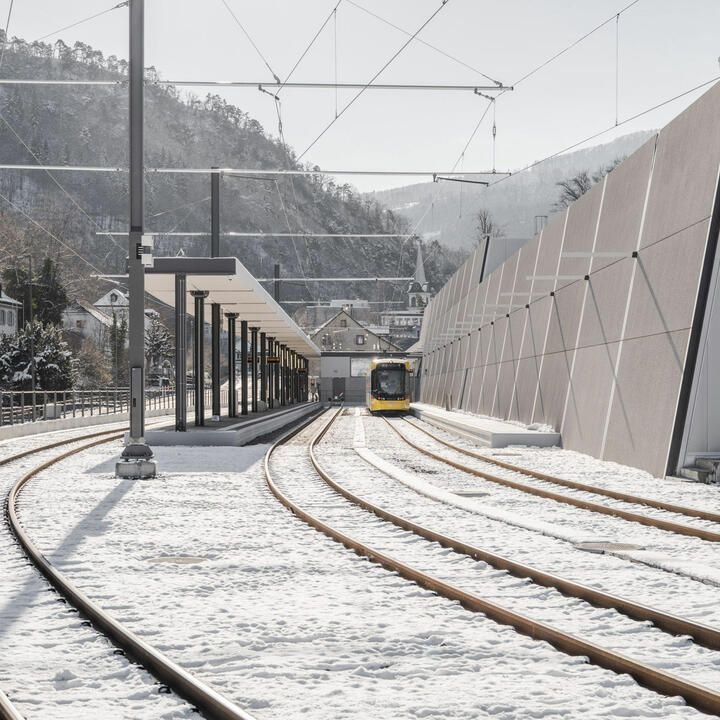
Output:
left=145, top=402, right=321, bottom=447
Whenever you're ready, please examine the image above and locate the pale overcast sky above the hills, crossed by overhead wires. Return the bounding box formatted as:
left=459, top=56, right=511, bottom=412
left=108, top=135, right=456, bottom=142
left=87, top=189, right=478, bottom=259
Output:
left=0, top=0, right=720, bottom=190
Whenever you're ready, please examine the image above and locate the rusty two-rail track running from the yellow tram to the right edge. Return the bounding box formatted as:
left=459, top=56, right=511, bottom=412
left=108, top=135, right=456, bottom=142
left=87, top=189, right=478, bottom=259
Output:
left=383, top=418, right=720, bottom=542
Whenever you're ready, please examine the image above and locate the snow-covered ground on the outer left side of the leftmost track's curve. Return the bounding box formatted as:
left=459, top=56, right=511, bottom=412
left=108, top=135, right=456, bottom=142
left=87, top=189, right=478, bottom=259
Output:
left=0, top=424, right=196, bottom=720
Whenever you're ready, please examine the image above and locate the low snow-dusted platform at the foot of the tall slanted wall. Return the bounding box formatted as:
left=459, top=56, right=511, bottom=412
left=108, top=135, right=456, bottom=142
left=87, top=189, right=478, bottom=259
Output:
left=410, top=403, right=562, bottom=448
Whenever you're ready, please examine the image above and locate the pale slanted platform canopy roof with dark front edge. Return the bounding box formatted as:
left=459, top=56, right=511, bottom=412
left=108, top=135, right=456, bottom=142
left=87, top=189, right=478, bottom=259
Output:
left=145, top=257, right=320, bottom=357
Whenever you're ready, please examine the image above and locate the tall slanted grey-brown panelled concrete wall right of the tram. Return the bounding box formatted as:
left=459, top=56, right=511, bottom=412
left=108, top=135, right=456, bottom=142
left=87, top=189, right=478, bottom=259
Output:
left=420, top=85, right=720, bottom=476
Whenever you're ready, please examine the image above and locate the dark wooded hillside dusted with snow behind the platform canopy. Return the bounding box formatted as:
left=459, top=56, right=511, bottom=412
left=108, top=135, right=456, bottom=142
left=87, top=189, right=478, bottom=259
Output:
left=0, top=32, right=464, bottom=308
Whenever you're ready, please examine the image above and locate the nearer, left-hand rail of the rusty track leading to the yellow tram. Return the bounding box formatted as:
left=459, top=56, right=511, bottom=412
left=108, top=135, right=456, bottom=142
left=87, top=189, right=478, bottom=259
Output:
left=383, top=418, right=720, bottom=542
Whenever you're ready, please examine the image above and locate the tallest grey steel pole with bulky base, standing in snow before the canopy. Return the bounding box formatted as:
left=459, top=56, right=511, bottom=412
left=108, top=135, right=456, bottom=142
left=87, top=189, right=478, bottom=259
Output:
left=115, top=0, right=157, bottom=477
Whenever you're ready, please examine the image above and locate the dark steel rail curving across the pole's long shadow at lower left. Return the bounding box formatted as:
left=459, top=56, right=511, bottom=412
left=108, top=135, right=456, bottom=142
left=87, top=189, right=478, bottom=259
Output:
left=5, top=433, right=254, bottom=720
